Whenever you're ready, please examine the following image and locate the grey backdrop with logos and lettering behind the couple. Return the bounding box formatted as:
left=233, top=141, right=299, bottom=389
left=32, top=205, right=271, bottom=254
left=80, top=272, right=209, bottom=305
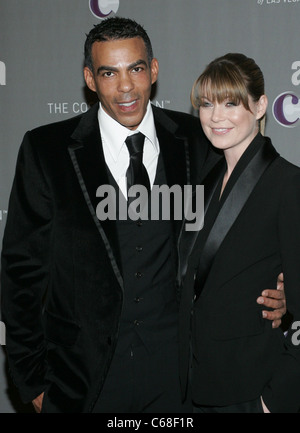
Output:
left=0, top=0, right=300, bottom=413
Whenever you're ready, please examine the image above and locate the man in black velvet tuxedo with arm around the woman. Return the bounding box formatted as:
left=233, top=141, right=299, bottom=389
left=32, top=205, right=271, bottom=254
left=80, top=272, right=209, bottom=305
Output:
left=2, top=17, right=282, bottom=413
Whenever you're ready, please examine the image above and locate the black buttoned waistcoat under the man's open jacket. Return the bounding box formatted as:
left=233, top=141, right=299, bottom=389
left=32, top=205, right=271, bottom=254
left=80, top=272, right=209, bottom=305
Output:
left=109, top=156, right=178, bottom=353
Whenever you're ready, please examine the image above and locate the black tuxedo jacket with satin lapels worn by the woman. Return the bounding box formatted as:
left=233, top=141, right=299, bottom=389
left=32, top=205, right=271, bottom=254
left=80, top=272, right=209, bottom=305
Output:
left=180, top=135, right=300, bottom=412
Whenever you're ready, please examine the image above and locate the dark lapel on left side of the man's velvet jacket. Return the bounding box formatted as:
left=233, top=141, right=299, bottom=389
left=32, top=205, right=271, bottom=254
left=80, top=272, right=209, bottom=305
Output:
left=69, top=104, right=123, bottom=287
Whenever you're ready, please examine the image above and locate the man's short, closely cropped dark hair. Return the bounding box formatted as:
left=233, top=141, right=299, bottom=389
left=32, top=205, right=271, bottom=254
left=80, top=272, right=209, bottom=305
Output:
left=84, top=17, right=153, bottom=71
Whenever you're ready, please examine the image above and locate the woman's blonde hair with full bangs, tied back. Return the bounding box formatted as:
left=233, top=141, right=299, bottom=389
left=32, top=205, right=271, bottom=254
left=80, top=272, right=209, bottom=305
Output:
left=191, top=53, right=265, bottom=133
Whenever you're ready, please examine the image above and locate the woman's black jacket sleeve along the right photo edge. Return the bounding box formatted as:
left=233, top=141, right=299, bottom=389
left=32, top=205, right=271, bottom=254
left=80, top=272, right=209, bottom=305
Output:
left=263, top=171, right=300, bottom=412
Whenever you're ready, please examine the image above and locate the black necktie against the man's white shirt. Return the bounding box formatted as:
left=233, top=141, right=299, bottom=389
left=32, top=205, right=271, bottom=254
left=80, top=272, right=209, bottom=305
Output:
left=125, top=132, right=150, bottom=200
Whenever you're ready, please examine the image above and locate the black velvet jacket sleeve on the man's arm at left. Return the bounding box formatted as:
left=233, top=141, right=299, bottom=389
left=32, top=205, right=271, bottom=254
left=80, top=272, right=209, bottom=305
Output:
left=1, top=133, right=53, bottom=402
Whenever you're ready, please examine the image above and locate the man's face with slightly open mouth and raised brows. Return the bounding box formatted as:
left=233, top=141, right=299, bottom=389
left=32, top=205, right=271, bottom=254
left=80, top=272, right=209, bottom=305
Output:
left=84, top=38, right=158, bottom=130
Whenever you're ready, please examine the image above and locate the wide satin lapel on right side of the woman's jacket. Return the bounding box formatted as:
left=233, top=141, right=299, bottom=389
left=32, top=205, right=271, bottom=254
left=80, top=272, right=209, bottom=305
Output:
left=195, top=139, right=278, bottom=297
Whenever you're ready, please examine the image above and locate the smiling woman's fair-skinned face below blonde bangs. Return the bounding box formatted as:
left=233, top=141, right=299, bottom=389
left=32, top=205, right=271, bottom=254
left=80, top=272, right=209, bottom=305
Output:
left=199, top=95, right=267, bottom=157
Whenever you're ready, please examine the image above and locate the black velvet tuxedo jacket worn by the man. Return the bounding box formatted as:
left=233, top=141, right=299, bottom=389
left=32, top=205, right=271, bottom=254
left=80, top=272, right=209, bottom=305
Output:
left=2, top=104, right=208, bottom=412
